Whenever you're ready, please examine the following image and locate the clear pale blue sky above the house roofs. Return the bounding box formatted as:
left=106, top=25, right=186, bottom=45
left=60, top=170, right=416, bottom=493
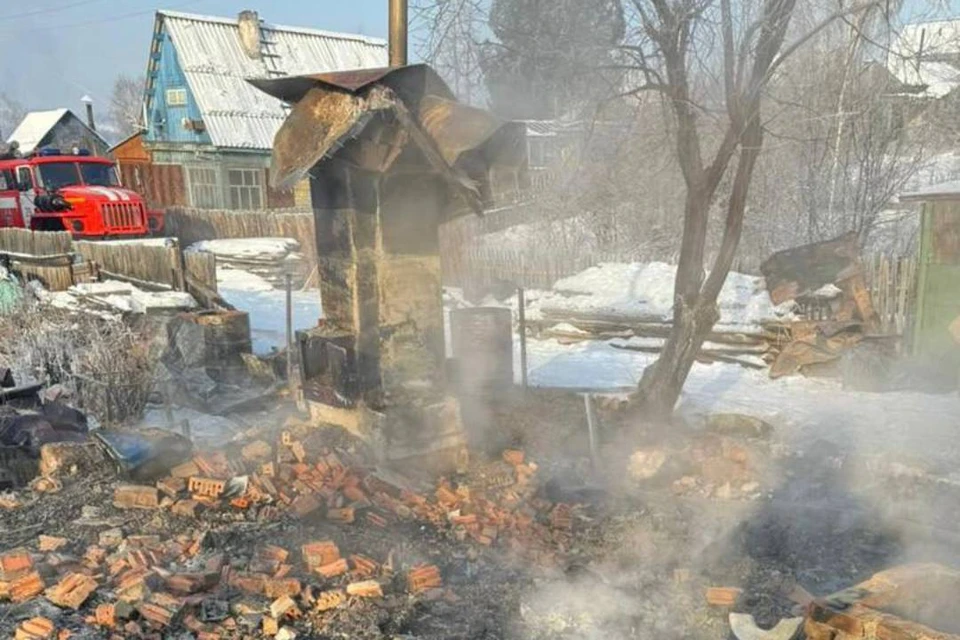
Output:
left=0, top=0, right=960, bottom=122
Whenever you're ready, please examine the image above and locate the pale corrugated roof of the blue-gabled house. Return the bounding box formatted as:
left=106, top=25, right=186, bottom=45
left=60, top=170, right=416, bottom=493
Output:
left=147, top=11, right=387, bottom=149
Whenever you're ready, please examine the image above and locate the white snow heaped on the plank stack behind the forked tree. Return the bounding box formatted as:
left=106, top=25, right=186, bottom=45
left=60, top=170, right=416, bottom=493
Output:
left=532, top=262, right=789, bottom=331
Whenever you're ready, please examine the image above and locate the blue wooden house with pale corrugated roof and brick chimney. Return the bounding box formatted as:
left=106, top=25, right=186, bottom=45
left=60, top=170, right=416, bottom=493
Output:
left=134, top=11, right=387, bottom=210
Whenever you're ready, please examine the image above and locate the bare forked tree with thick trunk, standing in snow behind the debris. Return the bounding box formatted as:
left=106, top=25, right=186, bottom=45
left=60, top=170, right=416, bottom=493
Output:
left=624, top=0, right=883, bottom=417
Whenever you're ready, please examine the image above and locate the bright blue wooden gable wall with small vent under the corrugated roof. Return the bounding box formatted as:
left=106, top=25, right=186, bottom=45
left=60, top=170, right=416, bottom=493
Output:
left=146, top=29, right=210, bottom=144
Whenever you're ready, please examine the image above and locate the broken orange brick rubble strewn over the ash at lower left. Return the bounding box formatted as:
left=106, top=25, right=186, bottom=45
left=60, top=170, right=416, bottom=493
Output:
left=0, top=432, right=575, bottom=640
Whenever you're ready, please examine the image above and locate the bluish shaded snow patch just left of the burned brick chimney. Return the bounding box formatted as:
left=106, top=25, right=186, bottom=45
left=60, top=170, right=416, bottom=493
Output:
left=217, top=266, right=323, bottom=354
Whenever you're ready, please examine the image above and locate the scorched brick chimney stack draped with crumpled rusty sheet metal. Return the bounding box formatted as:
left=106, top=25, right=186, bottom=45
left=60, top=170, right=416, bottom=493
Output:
left=250, top=65, right=525, bottom=472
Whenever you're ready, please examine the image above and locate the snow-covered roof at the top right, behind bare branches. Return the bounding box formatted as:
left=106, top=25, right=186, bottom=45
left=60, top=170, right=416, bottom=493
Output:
left=887, top=20, right=960, bottom=98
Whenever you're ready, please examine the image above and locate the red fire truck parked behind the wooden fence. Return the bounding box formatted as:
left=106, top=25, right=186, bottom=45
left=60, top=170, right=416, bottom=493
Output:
left=0, top=148, right=163, bottom=238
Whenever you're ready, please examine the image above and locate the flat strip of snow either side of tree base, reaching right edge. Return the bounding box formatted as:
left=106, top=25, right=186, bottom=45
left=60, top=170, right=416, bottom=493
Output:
left=514, top=338, right=960, bottom=463
